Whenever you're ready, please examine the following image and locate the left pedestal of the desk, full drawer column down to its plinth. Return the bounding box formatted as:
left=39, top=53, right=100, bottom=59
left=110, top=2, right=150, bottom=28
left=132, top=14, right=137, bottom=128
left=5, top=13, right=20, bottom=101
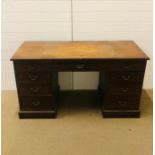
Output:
left=14, top=61, right=58, bottom=118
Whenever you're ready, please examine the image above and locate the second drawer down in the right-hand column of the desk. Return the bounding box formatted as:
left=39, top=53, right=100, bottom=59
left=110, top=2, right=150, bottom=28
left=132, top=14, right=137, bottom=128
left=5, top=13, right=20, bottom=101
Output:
left=109, top=72, right=144, bottom=84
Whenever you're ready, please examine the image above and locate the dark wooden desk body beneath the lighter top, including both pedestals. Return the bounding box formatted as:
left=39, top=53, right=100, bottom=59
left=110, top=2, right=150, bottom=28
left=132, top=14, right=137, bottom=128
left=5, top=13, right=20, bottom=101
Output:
left=14, top=59, right=146, bottom=118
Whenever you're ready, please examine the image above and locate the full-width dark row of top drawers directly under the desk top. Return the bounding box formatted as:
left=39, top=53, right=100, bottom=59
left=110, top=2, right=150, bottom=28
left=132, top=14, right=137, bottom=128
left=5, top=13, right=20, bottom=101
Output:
left=14, top=60, right=146, bottom=72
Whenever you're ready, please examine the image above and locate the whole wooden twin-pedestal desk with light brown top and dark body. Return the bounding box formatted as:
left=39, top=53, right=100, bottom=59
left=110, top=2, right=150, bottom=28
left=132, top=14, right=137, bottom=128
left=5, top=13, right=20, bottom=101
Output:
left=11, top=41, right=149, bottom=118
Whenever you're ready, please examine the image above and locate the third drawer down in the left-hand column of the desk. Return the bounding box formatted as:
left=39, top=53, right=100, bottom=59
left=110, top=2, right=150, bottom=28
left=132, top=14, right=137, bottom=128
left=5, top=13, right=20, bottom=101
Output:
left=18, top=83, right=52, bottom=96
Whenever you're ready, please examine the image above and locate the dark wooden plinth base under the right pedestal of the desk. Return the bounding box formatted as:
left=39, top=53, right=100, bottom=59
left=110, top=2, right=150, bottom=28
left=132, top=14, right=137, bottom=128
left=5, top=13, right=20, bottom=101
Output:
left=102, top=110, right=140, bottom=118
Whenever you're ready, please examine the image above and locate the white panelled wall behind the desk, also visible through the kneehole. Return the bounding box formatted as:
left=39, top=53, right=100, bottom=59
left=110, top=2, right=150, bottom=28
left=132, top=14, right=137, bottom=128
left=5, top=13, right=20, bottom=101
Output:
left=2, top=0, right=153, bottom=90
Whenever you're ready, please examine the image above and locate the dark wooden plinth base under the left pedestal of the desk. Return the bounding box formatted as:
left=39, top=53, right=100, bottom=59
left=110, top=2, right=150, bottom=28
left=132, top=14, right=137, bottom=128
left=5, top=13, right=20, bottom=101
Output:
left=18, top=111, right=57, bottom=119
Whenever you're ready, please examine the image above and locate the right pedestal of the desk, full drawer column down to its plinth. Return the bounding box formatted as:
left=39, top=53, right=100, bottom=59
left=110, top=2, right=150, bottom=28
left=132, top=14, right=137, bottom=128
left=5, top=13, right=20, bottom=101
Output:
left=103, top=60, right=146, bottom=117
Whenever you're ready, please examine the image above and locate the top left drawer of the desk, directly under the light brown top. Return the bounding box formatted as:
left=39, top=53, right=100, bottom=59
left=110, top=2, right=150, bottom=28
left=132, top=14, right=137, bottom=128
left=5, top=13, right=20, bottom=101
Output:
left=14, top=61, right=51, bottom=72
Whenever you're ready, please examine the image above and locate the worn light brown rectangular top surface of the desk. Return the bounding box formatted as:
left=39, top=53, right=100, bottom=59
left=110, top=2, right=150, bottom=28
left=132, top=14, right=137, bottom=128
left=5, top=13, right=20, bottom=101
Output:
left=11, top=41, right=149, bottom=60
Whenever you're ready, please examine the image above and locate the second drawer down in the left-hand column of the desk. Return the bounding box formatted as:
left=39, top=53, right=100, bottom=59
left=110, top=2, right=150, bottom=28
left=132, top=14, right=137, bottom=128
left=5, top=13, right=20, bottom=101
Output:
left=16, top=72, right=52, bottom=83
